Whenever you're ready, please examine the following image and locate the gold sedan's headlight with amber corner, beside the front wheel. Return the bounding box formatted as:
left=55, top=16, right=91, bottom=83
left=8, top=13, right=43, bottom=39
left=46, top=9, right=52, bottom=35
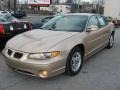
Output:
left=28, top=51, right=60, bottom=60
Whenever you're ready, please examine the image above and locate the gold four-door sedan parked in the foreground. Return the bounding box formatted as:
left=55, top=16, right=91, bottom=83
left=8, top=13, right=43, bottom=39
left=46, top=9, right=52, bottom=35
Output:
left=3, top=13, right=115, bottom=78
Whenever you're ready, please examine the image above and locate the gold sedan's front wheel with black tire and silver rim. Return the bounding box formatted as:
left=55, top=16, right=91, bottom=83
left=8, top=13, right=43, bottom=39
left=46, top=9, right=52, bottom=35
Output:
left=65, top=47, right=83, bottom=76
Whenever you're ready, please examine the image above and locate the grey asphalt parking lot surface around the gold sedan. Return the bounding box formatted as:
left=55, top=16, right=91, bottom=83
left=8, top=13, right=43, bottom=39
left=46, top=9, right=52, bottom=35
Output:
left=0, top=29, right=120, bottom=90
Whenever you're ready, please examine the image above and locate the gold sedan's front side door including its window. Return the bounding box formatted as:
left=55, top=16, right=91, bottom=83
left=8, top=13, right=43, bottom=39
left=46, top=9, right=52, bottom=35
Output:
left=85, top=15, right=101, bottom=57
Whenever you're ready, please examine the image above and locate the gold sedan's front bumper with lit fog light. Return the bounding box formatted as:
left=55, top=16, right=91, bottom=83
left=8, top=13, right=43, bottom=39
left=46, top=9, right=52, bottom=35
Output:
left=3, top=50, right=65, bottom=78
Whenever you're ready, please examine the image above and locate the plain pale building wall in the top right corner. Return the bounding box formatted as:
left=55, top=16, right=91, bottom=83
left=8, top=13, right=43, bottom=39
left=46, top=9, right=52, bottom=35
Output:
left=104, top=0, right=120, bottom=19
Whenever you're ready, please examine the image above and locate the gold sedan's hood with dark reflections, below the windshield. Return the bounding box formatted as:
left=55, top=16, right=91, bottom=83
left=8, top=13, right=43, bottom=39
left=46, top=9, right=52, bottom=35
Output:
left=6, top=30, right=78, bottom=53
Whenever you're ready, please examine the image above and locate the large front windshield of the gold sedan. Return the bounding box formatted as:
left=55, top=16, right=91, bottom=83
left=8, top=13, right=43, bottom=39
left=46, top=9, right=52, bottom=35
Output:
left=41, top=15, right=88, bottom=32
